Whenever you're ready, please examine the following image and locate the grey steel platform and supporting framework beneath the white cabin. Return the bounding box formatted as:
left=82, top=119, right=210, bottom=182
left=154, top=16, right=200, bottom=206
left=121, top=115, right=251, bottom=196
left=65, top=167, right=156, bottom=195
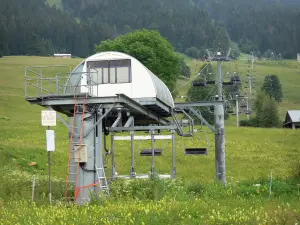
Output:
left=25, top=64, right=224, bottom=204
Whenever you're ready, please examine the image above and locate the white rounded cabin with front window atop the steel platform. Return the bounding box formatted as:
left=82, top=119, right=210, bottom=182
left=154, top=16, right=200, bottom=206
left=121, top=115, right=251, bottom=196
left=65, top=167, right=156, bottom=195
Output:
left=65, top=52, right=174, bottom=125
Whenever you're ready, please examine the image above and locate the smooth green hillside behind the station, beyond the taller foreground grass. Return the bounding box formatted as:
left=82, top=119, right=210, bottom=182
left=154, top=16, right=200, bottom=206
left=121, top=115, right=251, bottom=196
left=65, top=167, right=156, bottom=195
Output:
left=0, top=57, right=300, bottom=188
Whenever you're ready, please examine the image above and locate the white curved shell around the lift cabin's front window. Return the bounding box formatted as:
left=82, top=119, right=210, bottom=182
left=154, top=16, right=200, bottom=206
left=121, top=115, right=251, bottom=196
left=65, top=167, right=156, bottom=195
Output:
left=74, top=52, right=174, bottom=108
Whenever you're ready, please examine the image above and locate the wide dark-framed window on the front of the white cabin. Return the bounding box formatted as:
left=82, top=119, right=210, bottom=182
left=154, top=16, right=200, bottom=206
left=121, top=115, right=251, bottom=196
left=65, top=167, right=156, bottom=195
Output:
left=88, top=59, right=131, bottom=84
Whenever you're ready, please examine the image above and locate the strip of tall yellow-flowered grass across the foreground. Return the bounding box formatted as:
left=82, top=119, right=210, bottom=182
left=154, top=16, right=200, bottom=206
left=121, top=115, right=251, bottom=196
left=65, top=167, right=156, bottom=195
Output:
left=0, top=179, right=300, bottom=224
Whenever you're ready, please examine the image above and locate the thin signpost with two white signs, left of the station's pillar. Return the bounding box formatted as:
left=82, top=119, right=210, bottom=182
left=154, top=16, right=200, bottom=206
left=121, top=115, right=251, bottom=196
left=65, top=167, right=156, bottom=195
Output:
left=42, top=110, right=56, bottom=204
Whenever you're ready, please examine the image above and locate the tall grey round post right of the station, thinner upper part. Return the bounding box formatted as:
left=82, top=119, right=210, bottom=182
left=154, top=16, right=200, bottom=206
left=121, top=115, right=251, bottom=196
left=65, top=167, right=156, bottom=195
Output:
left=215, top=60, right=226, bottom=184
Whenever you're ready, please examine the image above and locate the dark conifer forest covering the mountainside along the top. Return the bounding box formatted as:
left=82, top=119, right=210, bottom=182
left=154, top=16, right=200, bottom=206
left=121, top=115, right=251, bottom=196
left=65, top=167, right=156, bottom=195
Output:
left=0, top=0, right=300, bottom=58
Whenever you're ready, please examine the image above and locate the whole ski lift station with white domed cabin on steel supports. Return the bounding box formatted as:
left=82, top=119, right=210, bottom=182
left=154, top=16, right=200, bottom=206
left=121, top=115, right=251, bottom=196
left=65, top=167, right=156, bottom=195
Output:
left=25, top=52, right=226, bottom=204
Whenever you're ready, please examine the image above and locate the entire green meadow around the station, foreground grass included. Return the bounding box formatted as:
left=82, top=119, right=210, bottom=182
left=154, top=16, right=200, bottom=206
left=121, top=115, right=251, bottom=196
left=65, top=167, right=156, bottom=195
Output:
left=0, top=57, right=300, bottom=224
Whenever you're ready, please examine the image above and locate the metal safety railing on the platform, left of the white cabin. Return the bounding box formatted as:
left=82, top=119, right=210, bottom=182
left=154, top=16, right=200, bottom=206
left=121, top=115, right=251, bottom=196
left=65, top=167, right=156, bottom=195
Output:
left=25, top=65, right=99, bottom=98
